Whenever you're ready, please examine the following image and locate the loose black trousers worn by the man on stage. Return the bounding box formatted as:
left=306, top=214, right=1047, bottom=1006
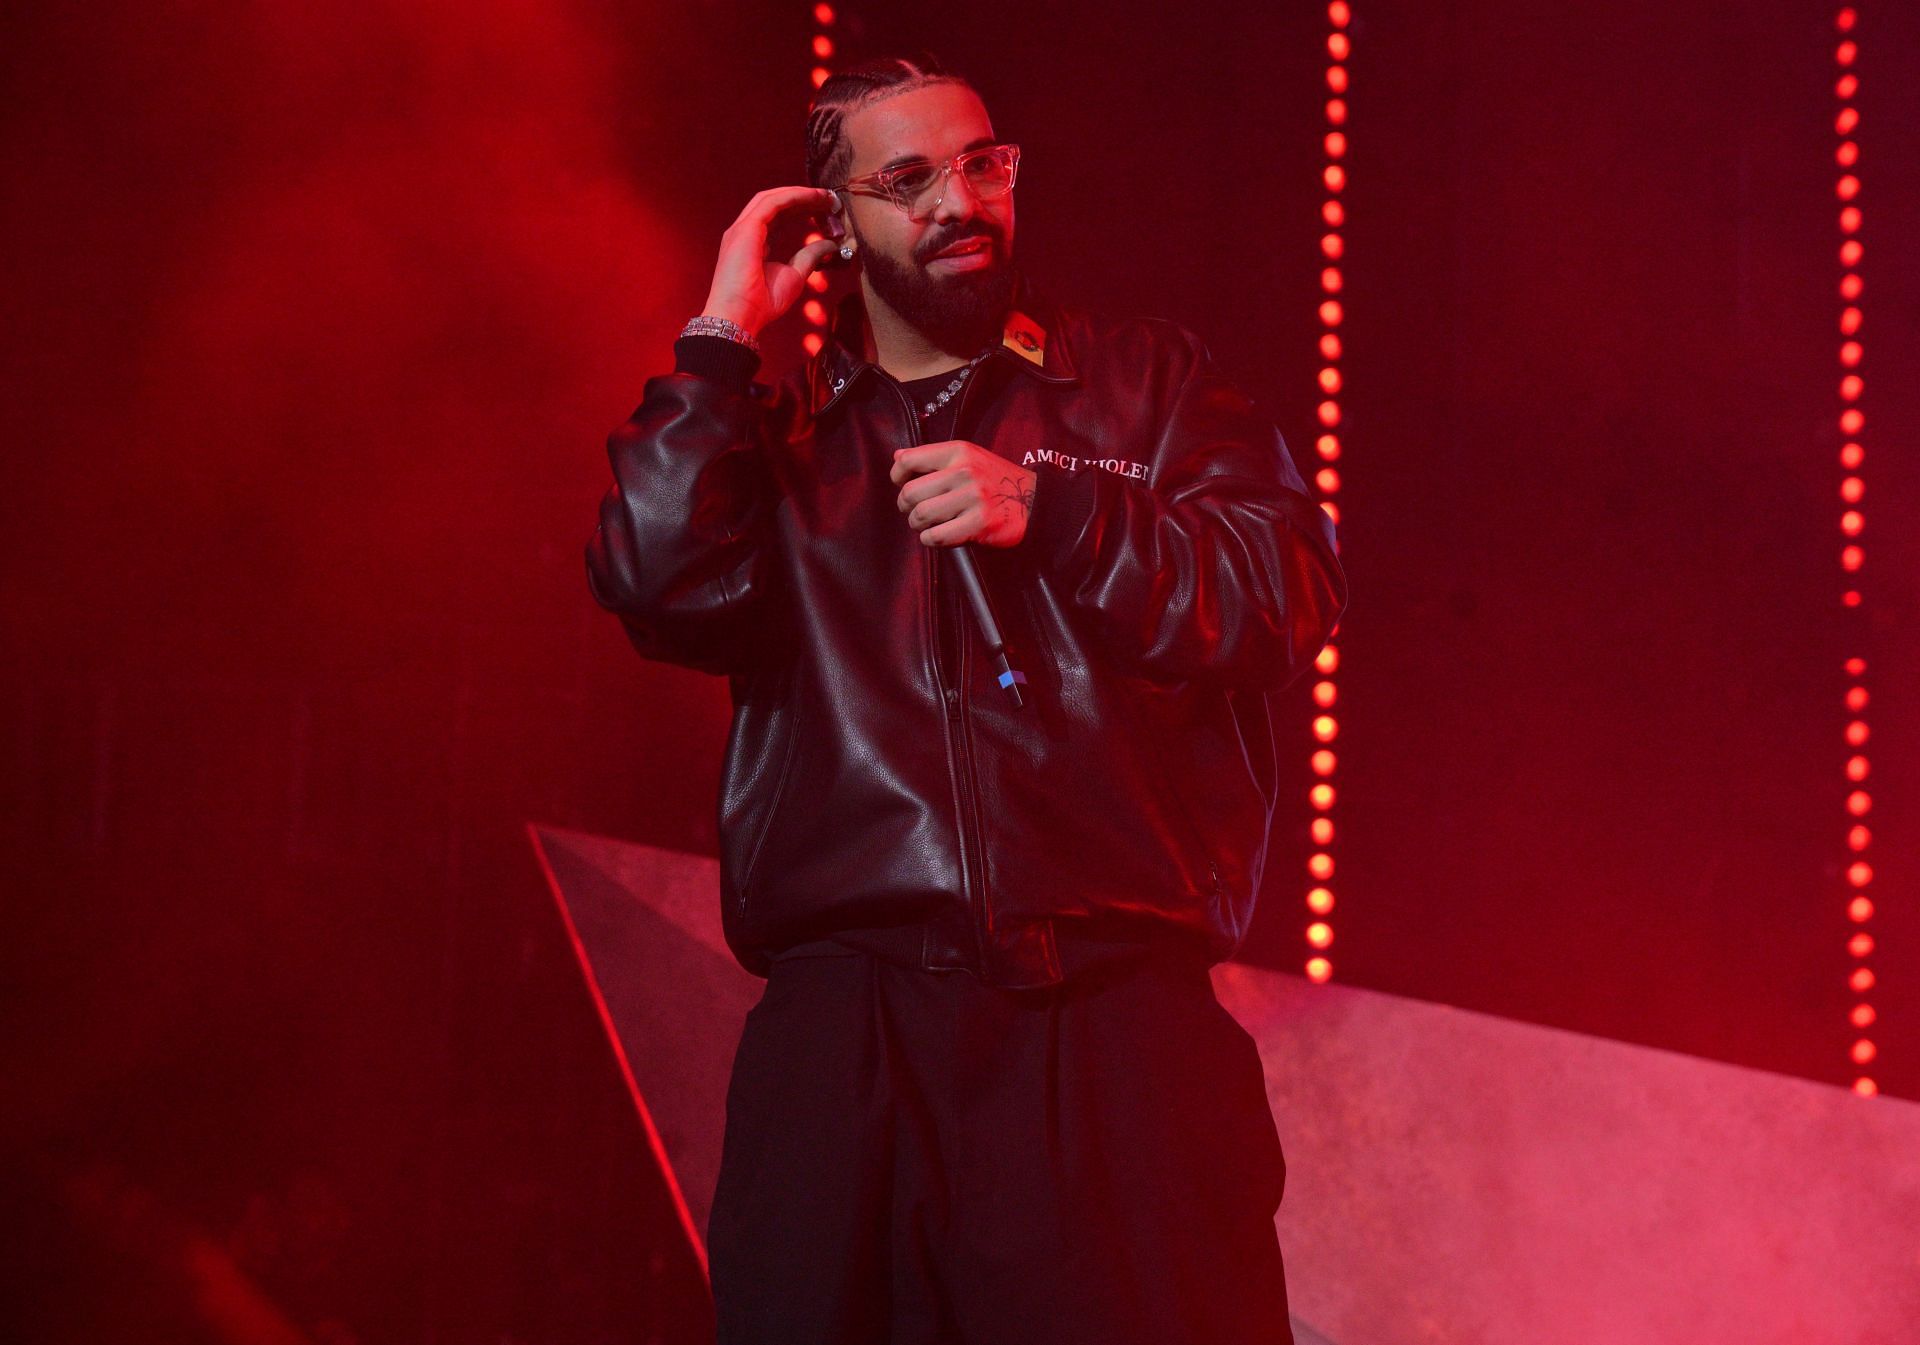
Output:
left=708, top=952, right=1292, bottom=1345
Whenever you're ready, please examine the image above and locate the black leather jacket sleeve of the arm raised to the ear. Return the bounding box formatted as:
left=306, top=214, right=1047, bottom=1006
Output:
left=586, top=351, right=774, bottom=673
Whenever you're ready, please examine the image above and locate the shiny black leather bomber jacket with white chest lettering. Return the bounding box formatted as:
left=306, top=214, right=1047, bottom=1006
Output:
left=586, top=280, right=1346, bottom=986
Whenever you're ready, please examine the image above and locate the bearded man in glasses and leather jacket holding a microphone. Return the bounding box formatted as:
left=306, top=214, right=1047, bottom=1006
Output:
left=588, top=59, right=1346, bottom=1345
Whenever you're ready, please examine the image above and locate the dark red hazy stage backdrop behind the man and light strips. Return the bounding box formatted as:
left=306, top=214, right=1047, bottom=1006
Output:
left=0, top=0, right=1920, bottom=1341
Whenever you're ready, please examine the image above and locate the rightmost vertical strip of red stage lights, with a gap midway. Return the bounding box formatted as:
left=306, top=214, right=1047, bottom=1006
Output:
left=1834, top=8, right=1880, bottom=1097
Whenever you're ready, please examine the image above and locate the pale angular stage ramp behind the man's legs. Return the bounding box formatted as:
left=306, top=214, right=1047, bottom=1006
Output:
left=530, top=827, right=1920, bottom=1345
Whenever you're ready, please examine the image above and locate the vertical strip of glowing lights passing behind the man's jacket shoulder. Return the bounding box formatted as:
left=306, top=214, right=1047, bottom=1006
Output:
left=1306, top=0, right=1354, bottom=982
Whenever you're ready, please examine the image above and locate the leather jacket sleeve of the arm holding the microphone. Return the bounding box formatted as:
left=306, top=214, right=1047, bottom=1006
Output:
left=1025, top=328, right=1346, bottom=691
